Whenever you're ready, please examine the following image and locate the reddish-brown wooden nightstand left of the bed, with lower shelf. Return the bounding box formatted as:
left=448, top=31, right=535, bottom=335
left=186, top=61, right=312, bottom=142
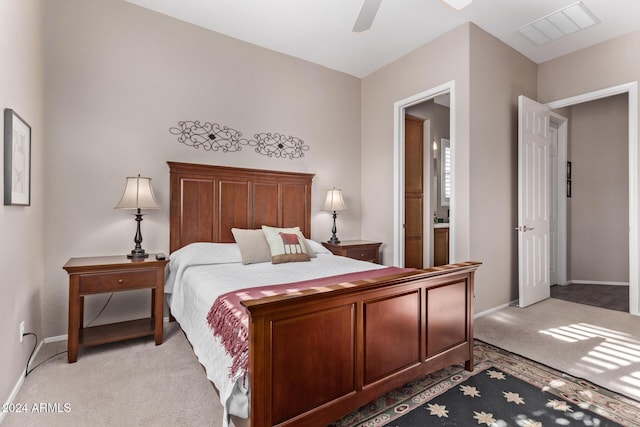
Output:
left=63, top=254, right=169, bottom=363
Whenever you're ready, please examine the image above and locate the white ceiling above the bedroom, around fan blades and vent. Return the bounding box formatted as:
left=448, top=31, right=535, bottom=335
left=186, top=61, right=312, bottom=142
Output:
left=126, top=0, right=640, bottom=77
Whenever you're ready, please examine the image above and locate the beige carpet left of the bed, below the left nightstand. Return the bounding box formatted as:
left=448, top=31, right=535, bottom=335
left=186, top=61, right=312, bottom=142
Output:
left=2, top=323, right=222, bottom=427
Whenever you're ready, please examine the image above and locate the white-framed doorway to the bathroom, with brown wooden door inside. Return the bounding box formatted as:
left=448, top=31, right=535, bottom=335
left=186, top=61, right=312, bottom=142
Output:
left=394, top=81, right=455, bottom=268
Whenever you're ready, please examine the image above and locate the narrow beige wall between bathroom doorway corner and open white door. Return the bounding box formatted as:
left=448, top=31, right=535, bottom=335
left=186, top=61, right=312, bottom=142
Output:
left=469, top=26, right=537, bottom=313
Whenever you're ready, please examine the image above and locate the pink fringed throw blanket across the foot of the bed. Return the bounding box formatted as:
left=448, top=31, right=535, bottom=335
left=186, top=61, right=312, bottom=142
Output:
left=207, top=267, right=413, bottom=378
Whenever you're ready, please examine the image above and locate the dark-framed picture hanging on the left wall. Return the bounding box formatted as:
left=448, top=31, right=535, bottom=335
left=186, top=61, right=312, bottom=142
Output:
left=4, top=108, right=31, bottom=206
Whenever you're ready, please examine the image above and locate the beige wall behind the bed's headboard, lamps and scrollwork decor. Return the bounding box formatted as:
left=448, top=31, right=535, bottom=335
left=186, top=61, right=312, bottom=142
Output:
left=44, top=0, right=360, bottom=336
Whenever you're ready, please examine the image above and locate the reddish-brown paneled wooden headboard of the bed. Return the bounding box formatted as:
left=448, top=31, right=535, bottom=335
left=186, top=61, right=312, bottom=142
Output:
left=167, top=162, right=314, bottom=252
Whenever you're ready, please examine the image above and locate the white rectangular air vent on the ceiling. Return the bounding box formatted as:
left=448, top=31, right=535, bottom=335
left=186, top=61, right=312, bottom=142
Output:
left=517, top=2, right=600, bottom=46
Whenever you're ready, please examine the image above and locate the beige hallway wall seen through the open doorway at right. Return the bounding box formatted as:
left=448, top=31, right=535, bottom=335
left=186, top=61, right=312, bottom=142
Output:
left=567, top=94, right=629, bottom=283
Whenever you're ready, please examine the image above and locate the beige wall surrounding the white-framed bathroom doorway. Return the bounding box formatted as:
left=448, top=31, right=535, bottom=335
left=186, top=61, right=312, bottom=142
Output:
left=362, top=24, right=470, bottom=264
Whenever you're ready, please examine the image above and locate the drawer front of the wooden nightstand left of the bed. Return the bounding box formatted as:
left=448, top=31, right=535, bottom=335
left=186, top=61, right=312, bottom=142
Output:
left=80, top=269, right=156, bottom=294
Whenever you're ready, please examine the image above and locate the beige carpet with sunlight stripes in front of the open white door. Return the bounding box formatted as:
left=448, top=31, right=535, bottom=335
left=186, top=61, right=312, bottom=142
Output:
left=474, top=298, right=640, bottom=400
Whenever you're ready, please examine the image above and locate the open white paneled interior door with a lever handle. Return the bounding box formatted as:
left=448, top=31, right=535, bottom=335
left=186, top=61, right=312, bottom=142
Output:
left=516, top=95, right=551, bottom=307
